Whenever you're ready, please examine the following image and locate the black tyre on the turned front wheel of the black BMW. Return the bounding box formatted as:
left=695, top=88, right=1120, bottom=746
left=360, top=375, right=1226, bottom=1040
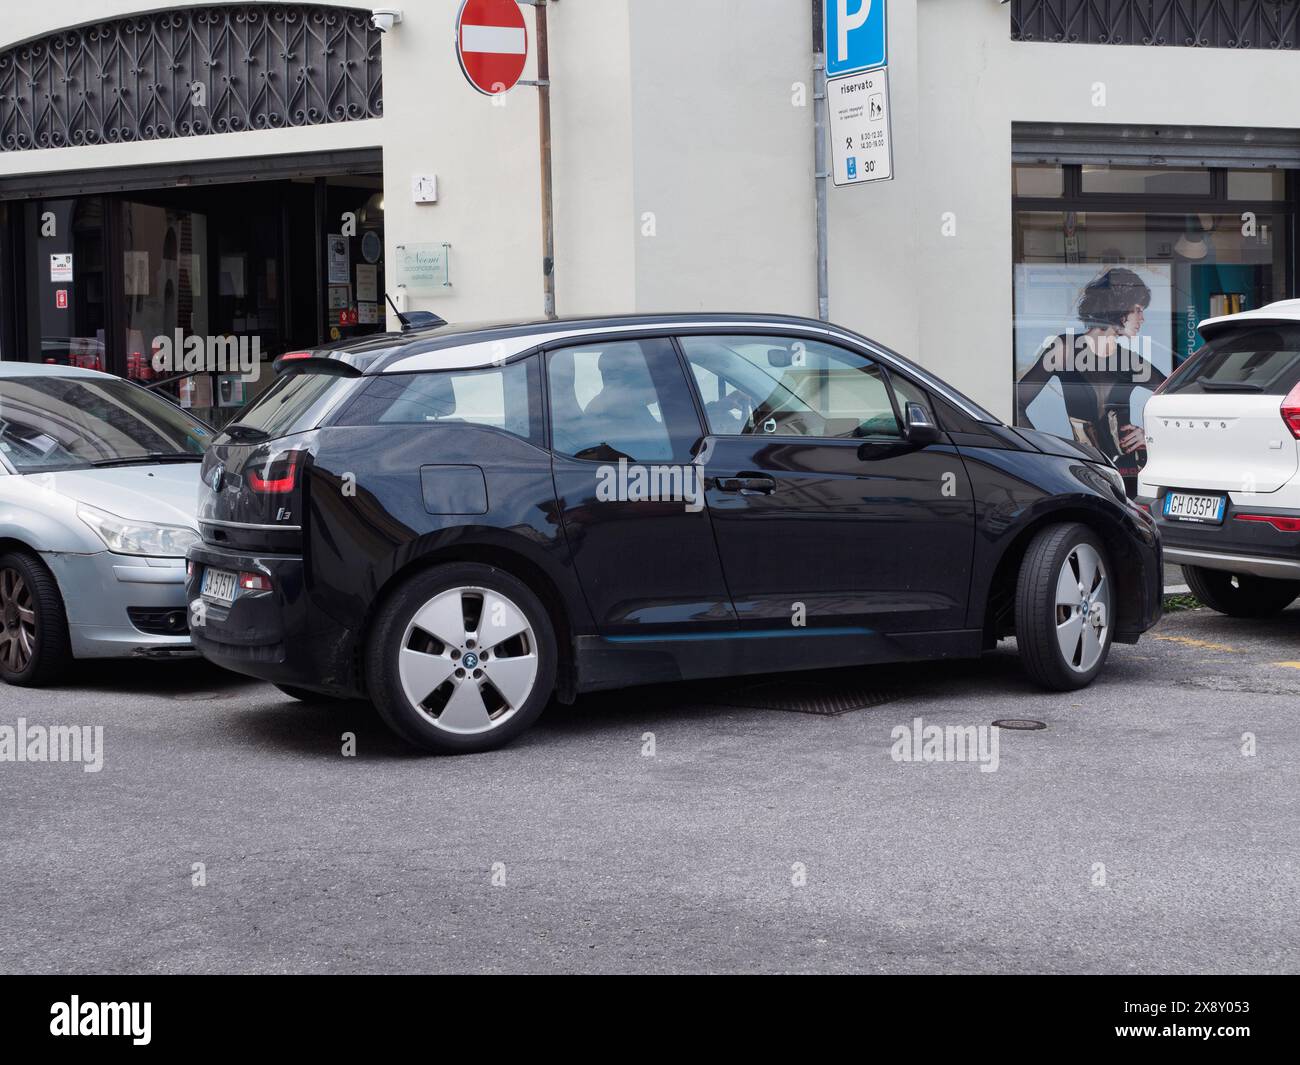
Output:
left=1015, top=521, right=1118, bottom=692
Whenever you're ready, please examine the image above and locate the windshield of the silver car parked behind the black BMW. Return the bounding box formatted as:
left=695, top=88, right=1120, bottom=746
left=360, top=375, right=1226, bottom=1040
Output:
left=0, top=376, right=212, bottom=473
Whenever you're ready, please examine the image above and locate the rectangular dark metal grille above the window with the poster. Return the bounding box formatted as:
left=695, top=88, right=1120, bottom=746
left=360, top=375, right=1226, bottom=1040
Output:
left=1011, top=0, right=1300, bottom=49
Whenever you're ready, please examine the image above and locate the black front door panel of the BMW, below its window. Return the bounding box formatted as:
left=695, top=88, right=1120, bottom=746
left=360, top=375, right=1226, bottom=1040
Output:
left=705, top=437, right=974, bottom=632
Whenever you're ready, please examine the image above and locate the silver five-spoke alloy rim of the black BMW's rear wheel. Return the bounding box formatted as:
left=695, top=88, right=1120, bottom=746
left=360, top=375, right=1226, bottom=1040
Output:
left=398, top=586, right=538, bottom=736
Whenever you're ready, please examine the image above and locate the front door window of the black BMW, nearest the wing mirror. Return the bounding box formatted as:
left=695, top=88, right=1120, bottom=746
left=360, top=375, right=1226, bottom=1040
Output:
left=681, top=337, right=902, bottom=438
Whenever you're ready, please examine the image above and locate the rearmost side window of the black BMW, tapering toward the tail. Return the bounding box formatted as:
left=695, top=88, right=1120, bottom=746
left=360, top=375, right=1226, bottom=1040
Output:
left=335, top=359, right=542, bottom=445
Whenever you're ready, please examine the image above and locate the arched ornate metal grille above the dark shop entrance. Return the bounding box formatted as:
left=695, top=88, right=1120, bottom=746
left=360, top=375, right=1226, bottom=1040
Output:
left=0, top=4, right=384, bottom=151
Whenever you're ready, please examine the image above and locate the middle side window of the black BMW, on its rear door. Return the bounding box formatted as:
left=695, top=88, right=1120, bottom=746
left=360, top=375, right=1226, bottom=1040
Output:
left=546, top=338, right=699, bottom=462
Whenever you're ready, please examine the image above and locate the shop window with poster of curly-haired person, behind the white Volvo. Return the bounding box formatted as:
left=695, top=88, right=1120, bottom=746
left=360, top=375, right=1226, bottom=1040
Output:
left=1014, top=166, right=1291, bottom=490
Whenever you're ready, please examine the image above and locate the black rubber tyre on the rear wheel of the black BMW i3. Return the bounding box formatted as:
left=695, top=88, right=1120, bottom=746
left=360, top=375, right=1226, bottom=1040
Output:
left=365, top=562, right=558, bottom=754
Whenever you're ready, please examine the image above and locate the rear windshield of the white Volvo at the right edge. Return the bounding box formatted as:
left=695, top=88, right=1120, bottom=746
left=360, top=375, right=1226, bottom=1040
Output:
left=1165, top=324, right=1300, bottom=395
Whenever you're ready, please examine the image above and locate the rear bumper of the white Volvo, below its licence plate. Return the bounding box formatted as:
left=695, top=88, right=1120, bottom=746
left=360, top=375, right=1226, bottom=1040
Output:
left=1141, top=489, right=1300, bottom=580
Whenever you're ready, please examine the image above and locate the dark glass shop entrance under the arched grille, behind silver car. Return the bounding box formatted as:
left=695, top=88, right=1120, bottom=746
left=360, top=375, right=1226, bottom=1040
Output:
left=0, top=150, right=385, bottom=425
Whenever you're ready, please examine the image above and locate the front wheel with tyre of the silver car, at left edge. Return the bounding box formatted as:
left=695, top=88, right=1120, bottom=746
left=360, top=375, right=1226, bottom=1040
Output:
left=0, top=551, right=72, bottom=688
